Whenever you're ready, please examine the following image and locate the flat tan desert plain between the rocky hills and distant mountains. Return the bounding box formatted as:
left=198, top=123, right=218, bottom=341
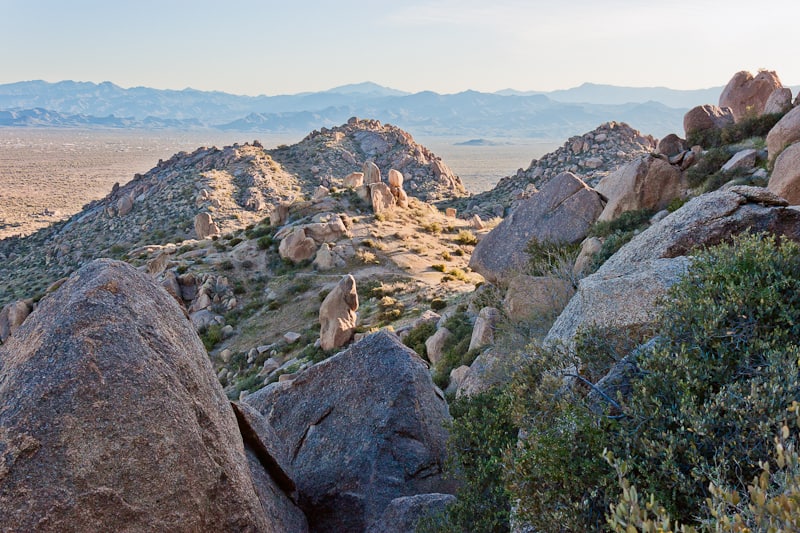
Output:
left=0, top=128, right=558, bottom=239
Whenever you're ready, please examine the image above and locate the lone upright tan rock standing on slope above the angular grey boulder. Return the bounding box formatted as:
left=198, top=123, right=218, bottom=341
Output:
left=319, top=274, right=358, bottom=350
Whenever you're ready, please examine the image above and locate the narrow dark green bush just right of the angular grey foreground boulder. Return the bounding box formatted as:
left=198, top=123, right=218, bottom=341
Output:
left=417, top=389, right=517, bottom=533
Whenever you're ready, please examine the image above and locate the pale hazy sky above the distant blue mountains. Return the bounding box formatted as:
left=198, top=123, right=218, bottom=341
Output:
left=0, top=0, right=800, bottom=95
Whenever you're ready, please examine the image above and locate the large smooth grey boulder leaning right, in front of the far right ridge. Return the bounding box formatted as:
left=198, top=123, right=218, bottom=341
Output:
left=469, top=173, right=603, bottom=283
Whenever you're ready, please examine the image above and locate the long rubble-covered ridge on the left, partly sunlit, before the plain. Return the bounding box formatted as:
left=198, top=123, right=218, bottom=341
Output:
left=0, top=119, right=467, bottom=302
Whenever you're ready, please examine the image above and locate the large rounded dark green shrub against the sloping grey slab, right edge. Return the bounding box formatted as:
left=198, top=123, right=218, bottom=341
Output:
left=622, top=234, right=800, bottom=522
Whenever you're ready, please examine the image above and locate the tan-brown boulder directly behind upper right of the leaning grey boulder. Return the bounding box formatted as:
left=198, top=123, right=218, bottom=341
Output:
left=595, top=156, right=685, bottom=221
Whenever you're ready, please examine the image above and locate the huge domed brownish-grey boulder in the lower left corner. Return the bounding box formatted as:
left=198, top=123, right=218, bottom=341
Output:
left=0, top=260, right=283, bottom=532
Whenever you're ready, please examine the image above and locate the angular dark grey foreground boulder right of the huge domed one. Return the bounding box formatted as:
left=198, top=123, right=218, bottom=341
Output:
left=244, top=332, right=450, bottom=532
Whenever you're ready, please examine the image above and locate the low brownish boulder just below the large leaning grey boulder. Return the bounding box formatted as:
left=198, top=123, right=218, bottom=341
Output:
left=503, top=276, right=575, bottom=320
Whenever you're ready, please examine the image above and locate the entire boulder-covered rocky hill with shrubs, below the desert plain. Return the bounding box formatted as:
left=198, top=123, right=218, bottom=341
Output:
left=0, top=68, right=800, bottom=533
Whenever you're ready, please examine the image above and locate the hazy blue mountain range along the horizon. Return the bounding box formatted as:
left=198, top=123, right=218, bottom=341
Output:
left=0, top=81, right=788, bottom=139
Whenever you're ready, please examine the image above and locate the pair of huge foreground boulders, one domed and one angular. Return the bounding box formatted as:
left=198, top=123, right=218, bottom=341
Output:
left=0, top=260, right=454, bottom=532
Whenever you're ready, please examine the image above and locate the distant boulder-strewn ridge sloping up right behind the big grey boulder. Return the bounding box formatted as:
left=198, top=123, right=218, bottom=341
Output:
left=452, top=122, right=656, bottom=217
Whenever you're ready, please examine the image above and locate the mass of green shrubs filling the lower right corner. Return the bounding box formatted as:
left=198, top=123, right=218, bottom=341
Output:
left=444, top=234, right=800, bottom=533
